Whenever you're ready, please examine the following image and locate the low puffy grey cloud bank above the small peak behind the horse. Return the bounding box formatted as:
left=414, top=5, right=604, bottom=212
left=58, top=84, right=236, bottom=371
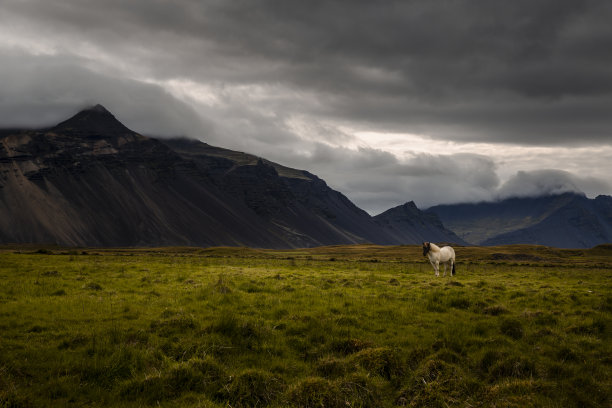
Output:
left=272, top=144, right=499, bottom=214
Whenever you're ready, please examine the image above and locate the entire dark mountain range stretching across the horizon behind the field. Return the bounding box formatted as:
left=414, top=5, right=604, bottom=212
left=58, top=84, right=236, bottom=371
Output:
left=0, top=105, right=612, bottom=248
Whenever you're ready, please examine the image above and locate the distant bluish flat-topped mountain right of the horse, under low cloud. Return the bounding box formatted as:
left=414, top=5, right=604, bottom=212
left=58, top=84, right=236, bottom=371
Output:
left=427, top=193, right=612, bottom=248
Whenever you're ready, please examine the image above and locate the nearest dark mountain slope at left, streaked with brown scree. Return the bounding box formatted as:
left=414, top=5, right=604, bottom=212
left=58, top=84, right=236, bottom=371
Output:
left=0, top=112, right=283, bottom=246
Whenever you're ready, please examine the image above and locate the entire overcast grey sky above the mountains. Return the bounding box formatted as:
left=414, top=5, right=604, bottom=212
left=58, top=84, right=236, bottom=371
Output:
left=0, top=0, right=612, bottom=214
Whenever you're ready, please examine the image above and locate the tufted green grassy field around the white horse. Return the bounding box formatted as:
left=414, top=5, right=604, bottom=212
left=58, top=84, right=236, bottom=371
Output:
left=0, top=246, right=612, bottom=407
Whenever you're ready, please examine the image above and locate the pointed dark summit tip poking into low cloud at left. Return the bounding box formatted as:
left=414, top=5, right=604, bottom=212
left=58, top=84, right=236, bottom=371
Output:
left=51, top=104, right=135, bottom=137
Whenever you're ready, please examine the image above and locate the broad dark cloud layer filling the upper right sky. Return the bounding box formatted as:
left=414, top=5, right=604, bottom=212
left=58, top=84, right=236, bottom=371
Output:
left=4, top=0, right=612, bottom=145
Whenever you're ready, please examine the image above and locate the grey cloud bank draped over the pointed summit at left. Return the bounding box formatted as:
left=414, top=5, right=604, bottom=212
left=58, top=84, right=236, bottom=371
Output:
left=0, top=52, right=212, bottom=136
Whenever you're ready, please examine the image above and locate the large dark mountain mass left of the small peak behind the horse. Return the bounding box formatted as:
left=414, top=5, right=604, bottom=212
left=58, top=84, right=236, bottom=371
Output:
left=0, top=105, right=454, bottom=248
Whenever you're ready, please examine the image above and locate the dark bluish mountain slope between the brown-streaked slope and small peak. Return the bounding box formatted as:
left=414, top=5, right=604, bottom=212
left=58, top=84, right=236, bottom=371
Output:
left=164, top=139, right=395, bottom=246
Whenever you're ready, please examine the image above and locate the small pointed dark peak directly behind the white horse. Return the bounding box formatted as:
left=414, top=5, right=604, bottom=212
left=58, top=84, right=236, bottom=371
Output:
left=374, top=201, right=467, bottom=245
